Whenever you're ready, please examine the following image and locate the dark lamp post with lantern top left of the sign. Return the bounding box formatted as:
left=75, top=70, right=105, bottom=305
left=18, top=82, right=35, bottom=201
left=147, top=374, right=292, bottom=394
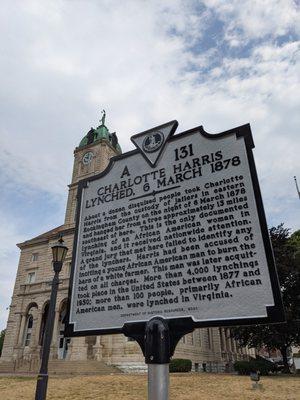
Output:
left=35, top=237, right=68, bottom=400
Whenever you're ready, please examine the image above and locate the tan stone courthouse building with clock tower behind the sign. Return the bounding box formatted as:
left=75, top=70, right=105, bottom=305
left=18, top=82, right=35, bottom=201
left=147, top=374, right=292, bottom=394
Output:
left=0, top=114, right=253, bottom=372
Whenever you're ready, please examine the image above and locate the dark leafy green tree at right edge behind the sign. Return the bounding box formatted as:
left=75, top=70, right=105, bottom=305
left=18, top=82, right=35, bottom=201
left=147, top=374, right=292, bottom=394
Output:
left=232, top=224, right=300, bottom=373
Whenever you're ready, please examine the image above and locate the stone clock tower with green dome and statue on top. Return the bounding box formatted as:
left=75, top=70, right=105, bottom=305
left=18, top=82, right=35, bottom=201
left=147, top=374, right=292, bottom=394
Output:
left=65, top=110, right=121, bottom=228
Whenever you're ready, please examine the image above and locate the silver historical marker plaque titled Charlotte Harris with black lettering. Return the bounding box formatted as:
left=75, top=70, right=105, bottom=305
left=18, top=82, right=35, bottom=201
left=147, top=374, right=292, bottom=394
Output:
left=66, top=121, right=284, bottom=336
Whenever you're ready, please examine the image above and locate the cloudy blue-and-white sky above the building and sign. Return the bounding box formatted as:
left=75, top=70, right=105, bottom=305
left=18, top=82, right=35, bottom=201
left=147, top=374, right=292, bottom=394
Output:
left=0, top=0, right=300, bottom=329
